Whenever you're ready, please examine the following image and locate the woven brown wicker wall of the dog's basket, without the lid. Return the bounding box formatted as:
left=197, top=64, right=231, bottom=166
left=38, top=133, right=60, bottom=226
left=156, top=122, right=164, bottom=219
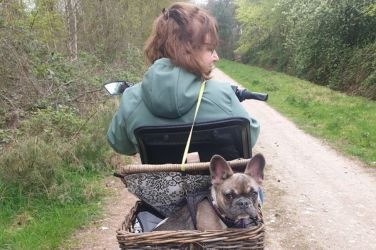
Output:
left=117, top=201, right=265, bottom=249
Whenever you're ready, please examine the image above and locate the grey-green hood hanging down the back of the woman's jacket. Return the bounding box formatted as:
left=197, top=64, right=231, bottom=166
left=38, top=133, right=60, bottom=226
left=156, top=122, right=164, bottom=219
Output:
left=141, top=58, right=201, bottom=118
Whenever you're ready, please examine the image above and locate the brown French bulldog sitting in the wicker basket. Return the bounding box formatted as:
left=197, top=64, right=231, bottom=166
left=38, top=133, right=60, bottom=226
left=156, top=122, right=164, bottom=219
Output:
left=154, top=154, right=265, bottom=231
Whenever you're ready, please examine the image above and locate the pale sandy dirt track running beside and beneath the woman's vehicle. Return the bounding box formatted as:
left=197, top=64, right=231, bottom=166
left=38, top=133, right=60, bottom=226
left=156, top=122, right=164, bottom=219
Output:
left=70, top=70, right=376, bottom=249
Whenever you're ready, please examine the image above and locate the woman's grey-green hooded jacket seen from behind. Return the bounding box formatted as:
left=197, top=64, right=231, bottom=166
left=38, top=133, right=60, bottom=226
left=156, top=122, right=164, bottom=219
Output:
left=107, top=58, right=260, bottom=155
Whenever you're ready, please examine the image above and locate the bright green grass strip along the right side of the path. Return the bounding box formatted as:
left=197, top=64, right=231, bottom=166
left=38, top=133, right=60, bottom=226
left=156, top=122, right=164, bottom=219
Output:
left=217, top=60, right=376, bottom=167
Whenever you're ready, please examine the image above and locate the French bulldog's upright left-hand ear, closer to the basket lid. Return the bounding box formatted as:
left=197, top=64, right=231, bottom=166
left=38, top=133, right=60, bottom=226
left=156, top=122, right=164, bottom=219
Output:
left=210, top=155, right=234, bottom=185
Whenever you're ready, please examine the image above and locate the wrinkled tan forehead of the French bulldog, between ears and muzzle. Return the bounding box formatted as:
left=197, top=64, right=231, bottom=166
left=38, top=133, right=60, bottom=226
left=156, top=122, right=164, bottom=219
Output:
left=222, top=173, right=258, bottom=194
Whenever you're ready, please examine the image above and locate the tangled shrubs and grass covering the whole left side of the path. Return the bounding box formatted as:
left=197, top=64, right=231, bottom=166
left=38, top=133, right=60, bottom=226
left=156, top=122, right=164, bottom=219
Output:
left=0, top=0, right=162, bottom=249
